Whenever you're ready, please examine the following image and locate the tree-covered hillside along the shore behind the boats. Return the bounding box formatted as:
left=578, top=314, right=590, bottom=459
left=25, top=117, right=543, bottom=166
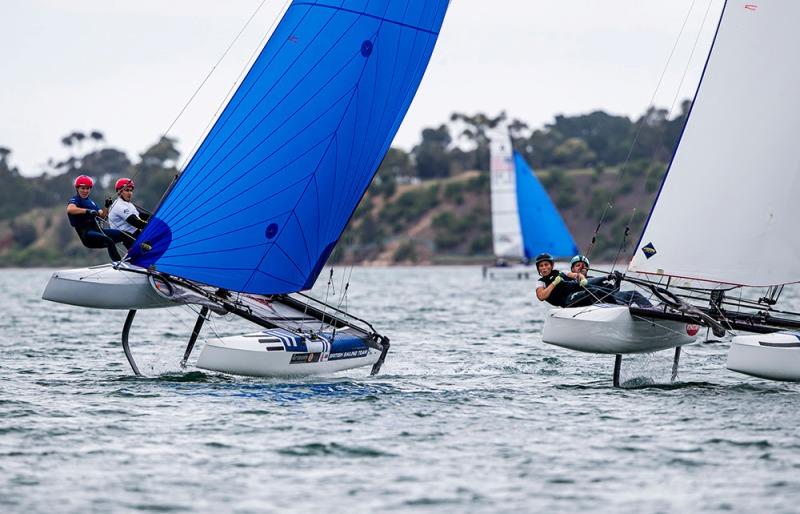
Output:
left=0, top=102, right=689, bottom=266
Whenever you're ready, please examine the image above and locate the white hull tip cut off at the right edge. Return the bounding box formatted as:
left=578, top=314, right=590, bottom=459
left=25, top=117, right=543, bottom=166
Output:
left=727, top=333, right=800, bottom=382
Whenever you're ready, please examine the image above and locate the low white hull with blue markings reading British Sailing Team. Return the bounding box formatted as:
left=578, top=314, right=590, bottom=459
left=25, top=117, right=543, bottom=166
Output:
left=196, top=331, right=381, bottom=377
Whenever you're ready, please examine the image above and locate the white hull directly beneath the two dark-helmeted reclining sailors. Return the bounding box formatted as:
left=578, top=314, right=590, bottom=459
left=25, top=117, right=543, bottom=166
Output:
left=542, top=304, right=697, bottom=354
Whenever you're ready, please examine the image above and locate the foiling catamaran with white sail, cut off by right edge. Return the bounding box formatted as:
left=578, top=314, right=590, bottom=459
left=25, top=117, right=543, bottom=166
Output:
left=542, top=0, right=800, bottom=381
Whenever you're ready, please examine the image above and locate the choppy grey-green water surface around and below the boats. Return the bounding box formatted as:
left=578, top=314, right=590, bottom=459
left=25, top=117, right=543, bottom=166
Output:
left=0, top=267, right=800, bottom=513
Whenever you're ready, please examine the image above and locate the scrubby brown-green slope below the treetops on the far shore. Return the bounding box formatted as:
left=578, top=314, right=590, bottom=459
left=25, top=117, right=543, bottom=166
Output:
left=0, top=166, right=663, bottom=266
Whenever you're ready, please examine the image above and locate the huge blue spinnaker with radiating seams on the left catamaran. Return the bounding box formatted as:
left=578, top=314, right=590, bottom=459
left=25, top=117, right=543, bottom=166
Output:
left=128, top=0, right=448, bottom=294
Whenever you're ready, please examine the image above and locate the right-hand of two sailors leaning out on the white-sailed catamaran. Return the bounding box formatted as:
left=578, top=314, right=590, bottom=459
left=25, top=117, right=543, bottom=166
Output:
left=566, top=255, right=652, bottom=307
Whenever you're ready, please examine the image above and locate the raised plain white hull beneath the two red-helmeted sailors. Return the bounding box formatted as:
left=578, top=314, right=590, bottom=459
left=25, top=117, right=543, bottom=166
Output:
left=42, top=264, right=177, bottom=310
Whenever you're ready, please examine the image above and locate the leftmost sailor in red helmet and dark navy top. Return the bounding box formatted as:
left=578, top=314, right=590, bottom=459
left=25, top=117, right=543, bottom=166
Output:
left=67, top=175, right=123, bottom=261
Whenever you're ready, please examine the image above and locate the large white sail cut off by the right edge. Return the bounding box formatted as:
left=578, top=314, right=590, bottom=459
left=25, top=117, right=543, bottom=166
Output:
left=630, top=0, right=800, bottom=286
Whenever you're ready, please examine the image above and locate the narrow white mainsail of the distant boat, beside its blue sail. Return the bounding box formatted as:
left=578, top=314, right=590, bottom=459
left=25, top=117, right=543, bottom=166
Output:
left=489, top=130, right=524, bottom=259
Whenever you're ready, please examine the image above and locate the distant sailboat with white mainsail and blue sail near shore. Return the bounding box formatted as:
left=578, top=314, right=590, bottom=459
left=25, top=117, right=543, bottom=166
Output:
left=484, top=131, right=578, bottom=278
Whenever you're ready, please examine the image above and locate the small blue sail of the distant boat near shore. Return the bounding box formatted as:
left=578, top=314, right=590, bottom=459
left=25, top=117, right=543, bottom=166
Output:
left=514, top=152, right=578, bottom=259
